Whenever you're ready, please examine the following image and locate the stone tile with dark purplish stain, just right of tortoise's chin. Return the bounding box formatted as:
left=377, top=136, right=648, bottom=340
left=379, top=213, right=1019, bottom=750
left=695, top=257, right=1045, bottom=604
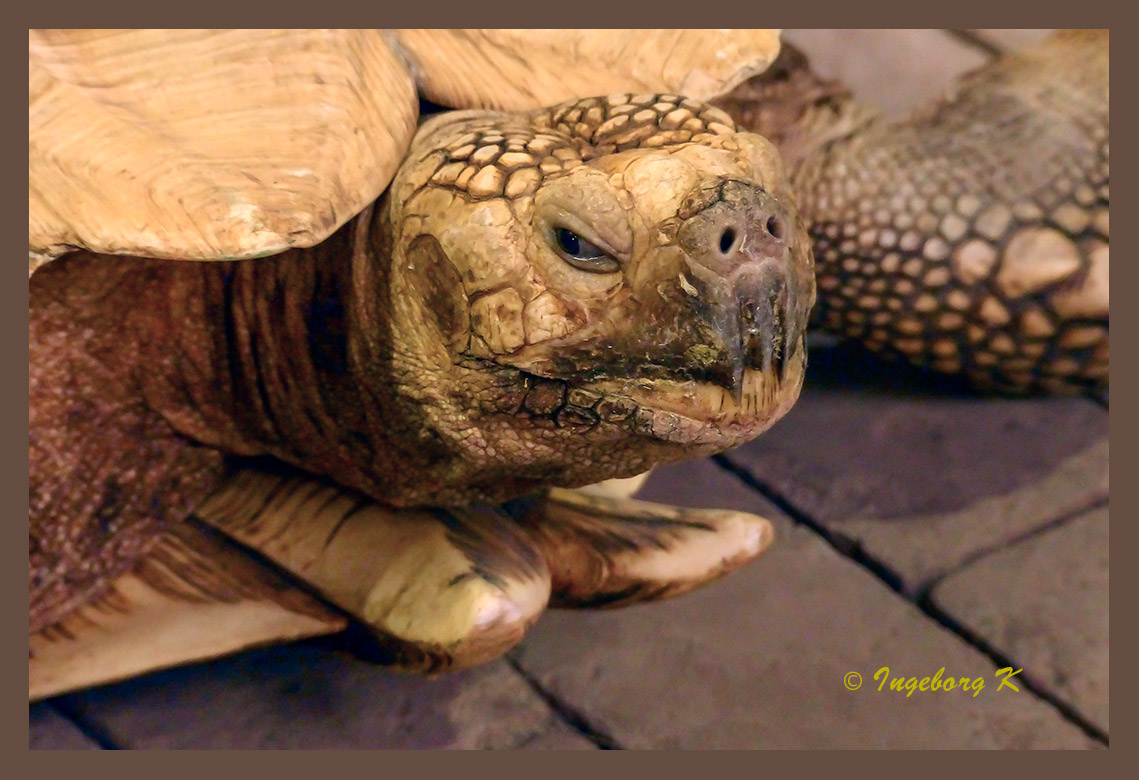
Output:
left=728, top=347, right=1108, bottom=592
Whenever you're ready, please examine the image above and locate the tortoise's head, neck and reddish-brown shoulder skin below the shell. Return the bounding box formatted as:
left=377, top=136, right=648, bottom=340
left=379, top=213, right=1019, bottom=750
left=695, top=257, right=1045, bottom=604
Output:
left=30, top=96, right=814, bottom=631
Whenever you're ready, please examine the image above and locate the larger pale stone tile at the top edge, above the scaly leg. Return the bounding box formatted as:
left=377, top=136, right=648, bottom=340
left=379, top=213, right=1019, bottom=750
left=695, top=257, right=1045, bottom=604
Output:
left=784, top=30, right=989, bottom=114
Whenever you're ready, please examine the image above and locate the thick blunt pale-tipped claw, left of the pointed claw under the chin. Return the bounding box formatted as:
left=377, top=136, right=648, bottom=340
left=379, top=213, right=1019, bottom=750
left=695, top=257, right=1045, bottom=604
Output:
left=196, top=470, right=550, bottom=673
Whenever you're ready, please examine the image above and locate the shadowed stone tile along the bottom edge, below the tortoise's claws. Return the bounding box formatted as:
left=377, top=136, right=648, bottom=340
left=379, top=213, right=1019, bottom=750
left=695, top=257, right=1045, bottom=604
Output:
left=53, top=642, right=593, bottom=749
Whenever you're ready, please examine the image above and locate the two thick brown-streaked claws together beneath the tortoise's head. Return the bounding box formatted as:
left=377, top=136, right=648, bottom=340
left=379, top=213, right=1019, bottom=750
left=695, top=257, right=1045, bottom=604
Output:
left=196, top=469, right=773, bottom=673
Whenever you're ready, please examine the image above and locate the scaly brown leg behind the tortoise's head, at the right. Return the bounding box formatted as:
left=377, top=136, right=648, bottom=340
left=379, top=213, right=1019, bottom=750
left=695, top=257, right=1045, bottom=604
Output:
left=716, top=31, right=1108, bottom=393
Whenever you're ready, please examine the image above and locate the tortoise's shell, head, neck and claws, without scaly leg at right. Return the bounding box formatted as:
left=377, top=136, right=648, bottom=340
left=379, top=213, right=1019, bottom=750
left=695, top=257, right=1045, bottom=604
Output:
left=30, top=31, right=801, bottom=697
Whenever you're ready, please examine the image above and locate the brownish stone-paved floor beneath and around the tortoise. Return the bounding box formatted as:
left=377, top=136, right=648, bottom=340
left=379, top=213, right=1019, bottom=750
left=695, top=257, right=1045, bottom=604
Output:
left=30, top=31, right=1108, bottom=749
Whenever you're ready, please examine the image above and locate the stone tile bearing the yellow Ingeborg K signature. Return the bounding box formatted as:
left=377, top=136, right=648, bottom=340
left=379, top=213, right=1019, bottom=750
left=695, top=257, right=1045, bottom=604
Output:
left=514, top=460, right=1095, bottom=748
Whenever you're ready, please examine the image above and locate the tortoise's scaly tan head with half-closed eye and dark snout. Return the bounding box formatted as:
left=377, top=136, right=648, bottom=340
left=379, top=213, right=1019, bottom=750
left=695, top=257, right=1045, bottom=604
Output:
left=373, top=95, right=814, bottom=498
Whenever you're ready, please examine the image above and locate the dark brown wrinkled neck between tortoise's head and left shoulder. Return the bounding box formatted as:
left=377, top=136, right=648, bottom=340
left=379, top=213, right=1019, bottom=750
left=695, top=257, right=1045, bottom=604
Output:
left=144, top=208, right=414, bottom=495
